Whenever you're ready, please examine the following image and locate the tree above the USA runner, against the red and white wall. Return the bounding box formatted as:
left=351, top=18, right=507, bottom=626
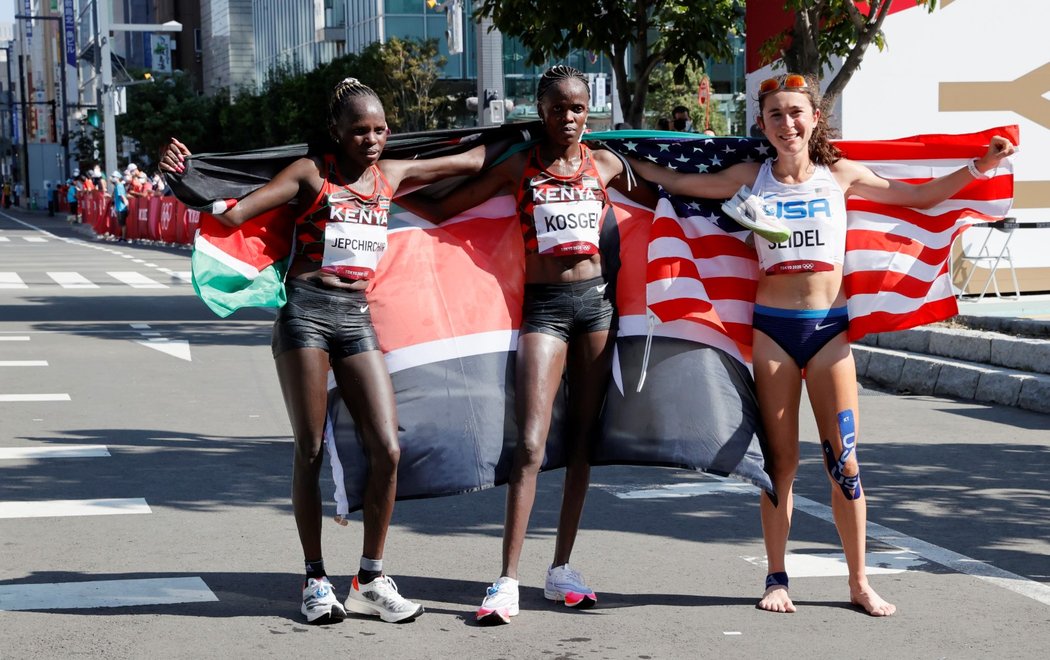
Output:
left=761, top=0, right=937, bottom=108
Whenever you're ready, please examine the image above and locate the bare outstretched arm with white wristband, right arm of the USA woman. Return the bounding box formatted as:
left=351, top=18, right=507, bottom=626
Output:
left=844, top=135, right=1016, bottom=209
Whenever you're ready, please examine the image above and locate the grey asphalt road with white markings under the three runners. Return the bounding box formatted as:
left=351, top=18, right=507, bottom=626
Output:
left=0, top=211, right=1050, bottom=660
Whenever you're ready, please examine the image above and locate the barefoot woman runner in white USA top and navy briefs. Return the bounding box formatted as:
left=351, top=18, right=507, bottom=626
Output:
left=632, top=73, right=1014, bottom=616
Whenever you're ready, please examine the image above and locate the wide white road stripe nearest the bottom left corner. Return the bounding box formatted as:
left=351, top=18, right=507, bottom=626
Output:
left=0, top=577, right=218, bottom=612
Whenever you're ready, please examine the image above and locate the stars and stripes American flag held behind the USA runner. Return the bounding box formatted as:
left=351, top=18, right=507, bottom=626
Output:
left=594, top=126, right=1019, bottom=361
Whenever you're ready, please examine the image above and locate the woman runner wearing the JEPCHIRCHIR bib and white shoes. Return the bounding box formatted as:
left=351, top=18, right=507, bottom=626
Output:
left=161, top=78, right=484, bottom=623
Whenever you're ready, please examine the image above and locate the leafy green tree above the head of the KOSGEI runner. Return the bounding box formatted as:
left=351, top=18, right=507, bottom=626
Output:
left=475, top=0, right=741, bottom=126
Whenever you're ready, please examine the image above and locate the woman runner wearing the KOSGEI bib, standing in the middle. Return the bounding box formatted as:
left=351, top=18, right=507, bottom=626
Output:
left=412, top=65, right=638, bottom=623
